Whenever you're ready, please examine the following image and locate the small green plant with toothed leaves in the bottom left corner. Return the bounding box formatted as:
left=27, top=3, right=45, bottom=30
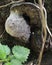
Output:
left=0, top=43, right=30, bottom=65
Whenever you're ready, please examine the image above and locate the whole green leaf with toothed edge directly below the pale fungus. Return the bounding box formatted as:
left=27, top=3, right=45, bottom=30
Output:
left=12, top=46, right=30, bottom=62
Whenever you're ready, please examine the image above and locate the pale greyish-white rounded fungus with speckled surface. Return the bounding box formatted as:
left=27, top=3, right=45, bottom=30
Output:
left=5, top=10, right=30, bottom=42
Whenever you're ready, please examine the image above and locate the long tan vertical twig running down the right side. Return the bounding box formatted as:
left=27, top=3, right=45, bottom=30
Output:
left=37, top=0, right=47, bottom=65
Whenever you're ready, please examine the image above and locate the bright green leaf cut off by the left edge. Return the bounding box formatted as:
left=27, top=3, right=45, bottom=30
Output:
left=0, top=43, right=10, bottom=59
